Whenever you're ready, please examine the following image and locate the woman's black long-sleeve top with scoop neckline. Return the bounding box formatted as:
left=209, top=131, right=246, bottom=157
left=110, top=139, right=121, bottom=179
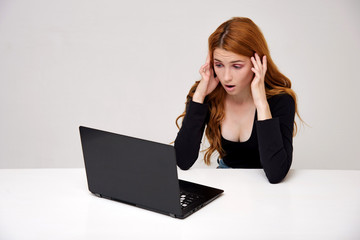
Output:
left=175, top=94, right=295, bottom=183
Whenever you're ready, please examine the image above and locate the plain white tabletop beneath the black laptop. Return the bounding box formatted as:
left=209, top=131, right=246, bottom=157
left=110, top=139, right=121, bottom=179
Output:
left=0, top=169, right=360, bottom=240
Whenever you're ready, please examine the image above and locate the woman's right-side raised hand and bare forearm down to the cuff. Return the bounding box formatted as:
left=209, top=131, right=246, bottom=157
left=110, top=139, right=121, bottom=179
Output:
left=251, top=53, right=271, bottom=120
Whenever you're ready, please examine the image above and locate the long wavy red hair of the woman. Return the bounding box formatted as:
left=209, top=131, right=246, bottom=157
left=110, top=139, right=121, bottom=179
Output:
left=176, top=17, right=301, bottom=165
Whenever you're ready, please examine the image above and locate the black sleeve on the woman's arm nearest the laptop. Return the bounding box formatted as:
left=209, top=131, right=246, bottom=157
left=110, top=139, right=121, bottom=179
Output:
left=175, top=101, right=209, bottom=170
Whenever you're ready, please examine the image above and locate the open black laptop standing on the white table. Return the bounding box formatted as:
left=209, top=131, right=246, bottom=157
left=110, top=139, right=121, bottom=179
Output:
left=79, top=126, right=224, bottom=219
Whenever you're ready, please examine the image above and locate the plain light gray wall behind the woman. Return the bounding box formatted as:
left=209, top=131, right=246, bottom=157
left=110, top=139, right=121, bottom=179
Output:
left=0, top=0, right=360, bottom=169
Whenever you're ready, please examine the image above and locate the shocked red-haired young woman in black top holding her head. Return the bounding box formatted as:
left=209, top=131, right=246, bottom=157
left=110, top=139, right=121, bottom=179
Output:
left=175, top=17, right=297, bottom=183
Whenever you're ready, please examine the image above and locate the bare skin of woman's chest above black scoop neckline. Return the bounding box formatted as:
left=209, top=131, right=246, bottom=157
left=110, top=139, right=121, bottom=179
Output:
left=221, top=101, right=256, bottom=142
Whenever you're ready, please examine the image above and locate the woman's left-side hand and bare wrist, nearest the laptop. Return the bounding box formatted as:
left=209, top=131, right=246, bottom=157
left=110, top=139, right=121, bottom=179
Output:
left=193, top=54, right=219, bottom=103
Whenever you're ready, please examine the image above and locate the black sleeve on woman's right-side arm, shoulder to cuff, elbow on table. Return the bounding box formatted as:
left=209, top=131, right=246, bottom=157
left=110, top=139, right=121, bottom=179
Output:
left=256, top=94, right=295, bottom=183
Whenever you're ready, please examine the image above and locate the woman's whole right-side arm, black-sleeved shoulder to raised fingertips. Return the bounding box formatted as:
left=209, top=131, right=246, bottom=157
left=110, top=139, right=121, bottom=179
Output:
left=251, top=53, right=295, bottom=183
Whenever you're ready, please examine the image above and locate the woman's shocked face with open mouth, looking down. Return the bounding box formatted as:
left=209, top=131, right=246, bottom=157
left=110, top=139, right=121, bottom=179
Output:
left=214, top=48, right=254, bottom=96
